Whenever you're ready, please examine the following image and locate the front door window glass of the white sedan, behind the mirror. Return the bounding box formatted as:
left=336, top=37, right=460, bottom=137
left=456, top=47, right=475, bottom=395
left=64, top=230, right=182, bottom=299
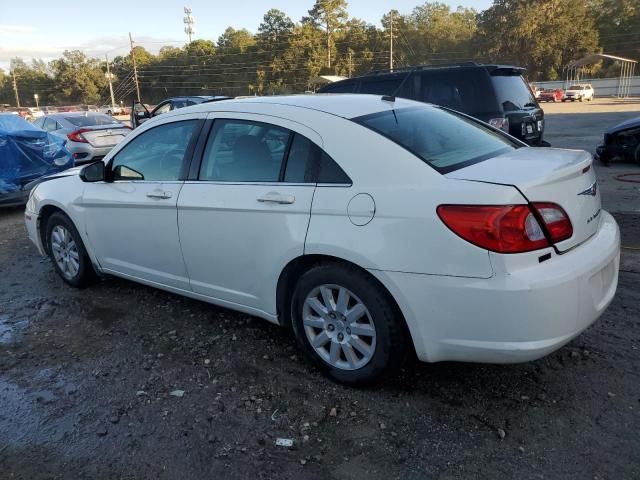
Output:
left=111, top=120, right=198, bottom=181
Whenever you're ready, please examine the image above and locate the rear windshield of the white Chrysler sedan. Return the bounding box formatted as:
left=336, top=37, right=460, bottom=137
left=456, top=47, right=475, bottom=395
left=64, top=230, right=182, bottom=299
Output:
left=353, top=106, right=520, bottom=173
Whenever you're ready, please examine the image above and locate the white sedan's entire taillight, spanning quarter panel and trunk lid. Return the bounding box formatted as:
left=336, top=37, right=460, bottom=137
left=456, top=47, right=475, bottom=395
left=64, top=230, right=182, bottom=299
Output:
left=437, top=203, right=573, bottom=253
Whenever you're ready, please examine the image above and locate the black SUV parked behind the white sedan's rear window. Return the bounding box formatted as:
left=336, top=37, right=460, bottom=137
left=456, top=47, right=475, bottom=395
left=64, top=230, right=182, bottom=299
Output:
left=318, top=62, right=548, bottom=146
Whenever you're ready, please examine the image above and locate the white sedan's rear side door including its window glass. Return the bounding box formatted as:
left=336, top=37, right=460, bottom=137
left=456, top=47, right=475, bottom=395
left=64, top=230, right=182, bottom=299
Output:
left=178, top=113, right=322, bottom=315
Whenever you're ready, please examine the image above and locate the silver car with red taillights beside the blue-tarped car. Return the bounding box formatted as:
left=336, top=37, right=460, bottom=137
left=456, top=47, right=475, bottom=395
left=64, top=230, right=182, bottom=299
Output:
left=33, top=112, right=131, bottom=165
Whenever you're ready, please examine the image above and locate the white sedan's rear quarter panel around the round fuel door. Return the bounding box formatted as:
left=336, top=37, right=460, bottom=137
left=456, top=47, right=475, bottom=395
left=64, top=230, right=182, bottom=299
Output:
left=305, top=119, right=525, bottom=278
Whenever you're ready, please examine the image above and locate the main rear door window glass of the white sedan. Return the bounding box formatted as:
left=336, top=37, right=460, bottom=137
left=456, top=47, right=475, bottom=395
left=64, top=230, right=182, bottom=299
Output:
left=199, top=120, right=291, bottom=182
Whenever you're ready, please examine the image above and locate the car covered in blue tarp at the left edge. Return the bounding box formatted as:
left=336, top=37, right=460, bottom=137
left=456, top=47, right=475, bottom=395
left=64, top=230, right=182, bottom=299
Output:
left=0, top=113, right=73, bottom=206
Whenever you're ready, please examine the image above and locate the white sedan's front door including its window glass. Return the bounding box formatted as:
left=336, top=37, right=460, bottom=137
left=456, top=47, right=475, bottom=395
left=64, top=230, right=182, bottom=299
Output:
left=82, top=116, right=202, bottom=290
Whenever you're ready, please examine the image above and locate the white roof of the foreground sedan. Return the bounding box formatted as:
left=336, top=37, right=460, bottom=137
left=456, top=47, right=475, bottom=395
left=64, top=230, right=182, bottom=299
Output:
left=175, top=93, right=425, bottom=118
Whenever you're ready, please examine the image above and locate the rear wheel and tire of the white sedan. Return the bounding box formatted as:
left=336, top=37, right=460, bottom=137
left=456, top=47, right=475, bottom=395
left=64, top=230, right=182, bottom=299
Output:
left=291, top=263, right=407, bottom=385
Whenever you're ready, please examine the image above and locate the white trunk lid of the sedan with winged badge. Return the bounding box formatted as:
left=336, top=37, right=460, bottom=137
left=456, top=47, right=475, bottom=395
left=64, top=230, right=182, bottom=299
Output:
left=446, top=148, right=601, bottom=252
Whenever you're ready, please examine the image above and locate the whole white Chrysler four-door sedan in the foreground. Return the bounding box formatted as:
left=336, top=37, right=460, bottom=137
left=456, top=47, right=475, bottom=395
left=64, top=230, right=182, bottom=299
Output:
left=25, top=95, right=620, bottom=383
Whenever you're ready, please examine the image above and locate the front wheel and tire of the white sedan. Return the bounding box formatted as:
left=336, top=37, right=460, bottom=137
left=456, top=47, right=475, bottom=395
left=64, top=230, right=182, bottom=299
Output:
left=46, top=212, right=97, bottom=288
